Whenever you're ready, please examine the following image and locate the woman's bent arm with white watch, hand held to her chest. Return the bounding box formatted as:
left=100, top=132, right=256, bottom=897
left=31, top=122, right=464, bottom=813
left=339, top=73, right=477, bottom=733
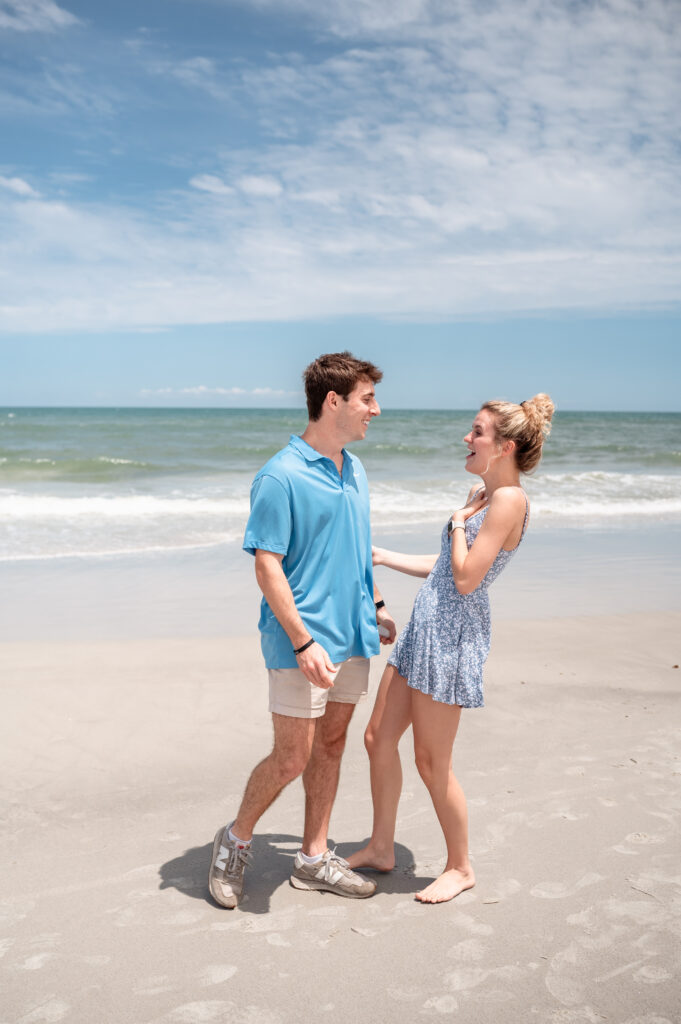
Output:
left=452, top=487, right=525, bottom=594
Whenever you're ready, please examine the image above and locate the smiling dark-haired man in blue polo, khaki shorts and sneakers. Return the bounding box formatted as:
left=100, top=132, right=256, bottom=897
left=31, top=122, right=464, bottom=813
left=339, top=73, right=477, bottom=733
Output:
left=209, top=352, right=395, bottom=908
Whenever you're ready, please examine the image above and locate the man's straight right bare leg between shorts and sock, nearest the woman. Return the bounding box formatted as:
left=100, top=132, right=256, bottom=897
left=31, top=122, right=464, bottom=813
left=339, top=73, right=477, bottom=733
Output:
left=303, top=700, right=355, bottom=857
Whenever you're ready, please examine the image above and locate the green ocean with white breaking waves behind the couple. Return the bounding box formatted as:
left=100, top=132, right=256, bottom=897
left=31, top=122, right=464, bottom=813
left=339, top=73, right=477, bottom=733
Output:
left=0, top=408, right=681, bottom=562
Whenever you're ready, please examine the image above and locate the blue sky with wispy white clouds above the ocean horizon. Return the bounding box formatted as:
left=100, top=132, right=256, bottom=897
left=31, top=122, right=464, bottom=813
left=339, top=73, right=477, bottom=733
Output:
left=0, top=0, right=681, bottom=410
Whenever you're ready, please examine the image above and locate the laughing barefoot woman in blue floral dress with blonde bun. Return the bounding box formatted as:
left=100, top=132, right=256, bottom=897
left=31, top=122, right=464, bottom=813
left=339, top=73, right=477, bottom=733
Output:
left=348, top=394, right=554, bottom=903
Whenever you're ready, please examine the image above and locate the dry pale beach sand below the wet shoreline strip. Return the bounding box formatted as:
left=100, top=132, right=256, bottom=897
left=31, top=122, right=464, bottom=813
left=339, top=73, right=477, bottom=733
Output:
left=0, top=611, right=681, bottom=1024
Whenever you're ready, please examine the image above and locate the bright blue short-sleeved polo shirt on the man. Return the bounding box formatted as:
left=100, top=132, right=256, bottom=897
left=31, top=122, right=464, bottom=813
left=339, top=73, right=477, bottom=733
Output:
left=244, top=434, right=379, bottom=669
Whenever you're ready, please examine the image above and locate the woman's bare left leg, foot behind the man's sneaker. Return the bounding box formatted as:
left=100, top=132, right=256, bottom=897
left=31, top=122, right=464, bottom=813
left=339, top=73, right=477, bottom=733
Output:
left=347, top=665, right=412, bottom=871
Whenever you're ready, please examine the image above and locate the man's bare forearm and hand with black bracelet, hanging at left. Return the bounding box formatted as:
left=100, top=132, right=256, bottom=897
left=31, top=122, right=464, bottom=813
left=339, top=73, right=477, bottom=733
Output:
left=255, top=548, right=336, bottom=690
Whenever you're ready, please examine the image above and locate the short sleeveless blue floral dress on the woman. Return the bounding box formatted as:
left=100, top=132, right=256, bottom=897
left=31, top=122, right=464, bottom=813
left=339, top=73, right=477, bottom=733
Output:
left=388, top=497, right=529, bottom=708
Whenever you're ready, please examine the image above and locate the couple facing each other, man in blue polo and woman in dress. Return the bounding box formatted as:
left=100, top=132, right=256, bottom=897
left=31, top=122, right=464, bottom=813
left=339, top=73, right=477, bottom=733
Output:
left=209, top=352, right=553, bottom=908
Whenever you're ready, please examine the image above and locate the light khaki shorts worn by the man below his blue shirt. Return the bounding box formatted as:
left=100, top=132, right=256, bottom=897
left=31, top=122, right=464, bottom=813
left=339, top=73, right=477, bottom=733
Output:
left=267, top=656, right=369, bottom=718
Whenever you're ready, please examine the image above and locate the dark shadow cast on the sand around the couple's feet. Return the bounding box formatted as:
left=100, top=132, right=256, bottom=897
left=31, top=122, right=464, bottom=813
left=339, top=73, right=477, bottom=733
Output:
left=159, top=835, right=432, bottom=913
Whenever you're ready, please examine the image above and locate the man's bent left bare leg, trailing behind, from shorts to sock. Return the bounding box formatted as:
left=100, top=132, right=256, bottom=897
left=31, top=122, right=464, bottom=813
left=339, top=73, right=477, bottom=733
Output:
left=231, top=714, right=315, bottom=842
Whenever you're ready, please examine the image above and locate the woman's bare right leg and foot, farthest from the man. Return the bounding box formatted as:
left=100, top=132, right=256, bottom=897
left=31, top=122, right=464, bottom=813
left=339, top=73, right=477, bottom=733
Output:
left=411, top=690, right=475, bottom=903
